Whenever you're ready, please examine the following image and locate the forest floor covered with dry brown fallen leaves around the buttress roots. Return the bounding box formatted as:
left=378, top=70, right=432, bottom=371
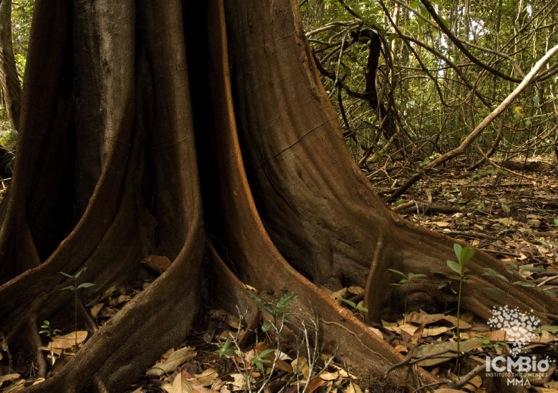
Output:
left=0, top=157, right=558, bottom=393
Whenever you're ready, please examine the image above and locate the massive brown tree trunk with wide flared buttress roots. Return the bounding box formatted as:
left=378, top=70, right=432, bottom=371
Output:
left=0, top=0, right=558, bottom=392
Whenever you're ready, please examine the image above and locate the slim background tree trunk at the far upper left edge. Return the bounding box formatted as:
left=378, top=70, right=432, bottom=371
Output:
left=0, top=0, right=21, bottom=130
